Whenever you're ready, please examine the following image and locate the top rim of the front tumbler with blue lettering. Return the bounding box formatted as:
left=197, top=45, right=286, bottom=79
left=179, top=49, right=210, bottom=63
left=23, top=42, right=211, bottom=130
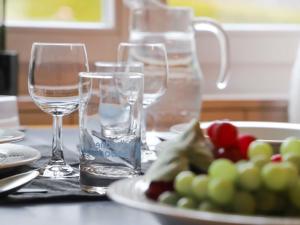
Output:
left=79, top=71, right=144, bottom=79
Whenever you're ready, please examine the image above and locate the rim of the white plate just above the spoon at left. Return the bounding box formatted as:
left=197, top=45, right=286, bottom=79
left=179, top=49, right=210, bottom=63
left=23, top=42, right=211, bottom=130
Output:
left=0, top=143, right=41, bottom=170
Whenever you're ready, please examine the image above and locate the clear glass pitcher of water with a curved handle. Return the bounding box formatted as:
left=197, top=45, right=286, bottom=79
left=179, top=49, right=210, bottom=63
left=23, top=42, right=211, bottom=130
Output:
left=129, top=5, right=228, bottom=130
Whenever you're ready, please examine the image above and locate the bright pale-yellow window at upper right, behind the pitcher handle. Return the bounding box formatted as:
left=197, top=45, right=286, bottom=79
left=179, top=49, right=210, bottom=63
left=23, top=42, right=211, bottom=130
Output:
left=168, top=0, right=300, bottom=23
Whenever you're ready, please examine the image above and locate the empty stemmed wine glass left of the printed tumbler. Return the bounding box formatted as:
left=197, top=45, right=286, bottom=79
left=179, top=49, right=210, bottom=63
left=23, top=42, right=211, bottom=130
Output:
left=28, top=43, right=88, bottom=178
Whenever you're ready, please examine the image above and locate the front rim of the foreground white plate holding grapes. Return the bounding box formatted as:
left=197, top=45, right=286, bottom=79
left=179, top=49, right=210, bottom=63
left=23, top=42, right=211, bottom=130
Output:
left=107, top=177, right=300, bottom=225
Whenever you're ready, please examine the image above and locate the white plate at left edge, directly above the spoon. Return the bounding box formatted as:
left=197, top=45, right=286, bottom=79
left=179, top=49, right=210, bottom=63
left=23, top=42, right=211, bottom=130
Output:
left=0, top=144, right=41, bottom=169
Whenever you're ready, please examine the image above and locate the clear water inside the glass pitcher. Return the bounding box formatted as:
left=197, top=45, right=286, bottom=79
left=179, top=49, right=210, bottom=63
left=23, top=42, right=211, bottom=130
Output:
left=130, top=31, right=202, bottom=130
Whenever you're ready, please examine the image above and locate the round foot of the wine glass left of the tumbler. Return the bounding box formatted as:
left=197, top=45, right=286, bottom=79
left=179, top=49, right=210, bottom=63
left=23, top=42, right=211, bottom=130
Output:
left=40, top=165, right=79, bottom=179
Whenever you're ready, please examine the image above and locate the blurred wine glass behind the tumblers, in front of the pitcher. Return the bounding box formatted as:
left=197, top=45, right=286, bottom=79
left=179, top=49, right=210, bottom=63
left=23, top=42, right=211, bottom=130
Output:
left=118, top=43, right=169, bottom=162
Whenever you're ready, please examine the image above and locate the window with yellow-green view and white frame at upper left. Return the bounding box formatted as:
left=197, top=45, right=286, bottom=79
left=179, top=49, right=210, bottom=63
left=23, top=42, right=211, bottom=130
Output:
left=6, top=0, right=113, bottom=28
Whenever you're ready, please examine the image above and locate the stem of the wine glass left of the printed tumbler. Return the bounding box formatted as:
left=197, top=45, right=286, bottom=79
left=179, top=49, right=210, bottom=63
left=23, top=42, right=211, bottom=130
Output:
left=50, top=115, right=65, bottom=165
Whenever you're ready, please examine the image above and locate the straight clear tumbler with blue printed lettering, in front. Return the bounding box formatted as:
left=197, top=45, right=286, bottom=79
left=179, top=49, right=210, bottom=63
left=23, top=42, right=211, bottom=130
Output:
left=79, top=64, right=144, bottom=194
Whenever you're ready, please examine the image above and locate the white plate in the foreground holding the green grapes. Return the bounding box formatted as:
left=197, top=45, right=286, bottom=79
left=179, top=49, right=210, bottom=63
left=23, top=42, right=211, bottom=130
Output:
left=107, top=177, right=300, bottom=225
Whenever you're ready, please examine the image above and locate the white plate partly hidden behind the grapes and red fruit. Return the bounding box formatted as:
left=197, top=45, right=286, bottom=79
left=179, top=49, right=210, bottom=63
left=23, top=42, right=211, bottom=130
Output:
left=170, top=121, right=300, bottom=142
